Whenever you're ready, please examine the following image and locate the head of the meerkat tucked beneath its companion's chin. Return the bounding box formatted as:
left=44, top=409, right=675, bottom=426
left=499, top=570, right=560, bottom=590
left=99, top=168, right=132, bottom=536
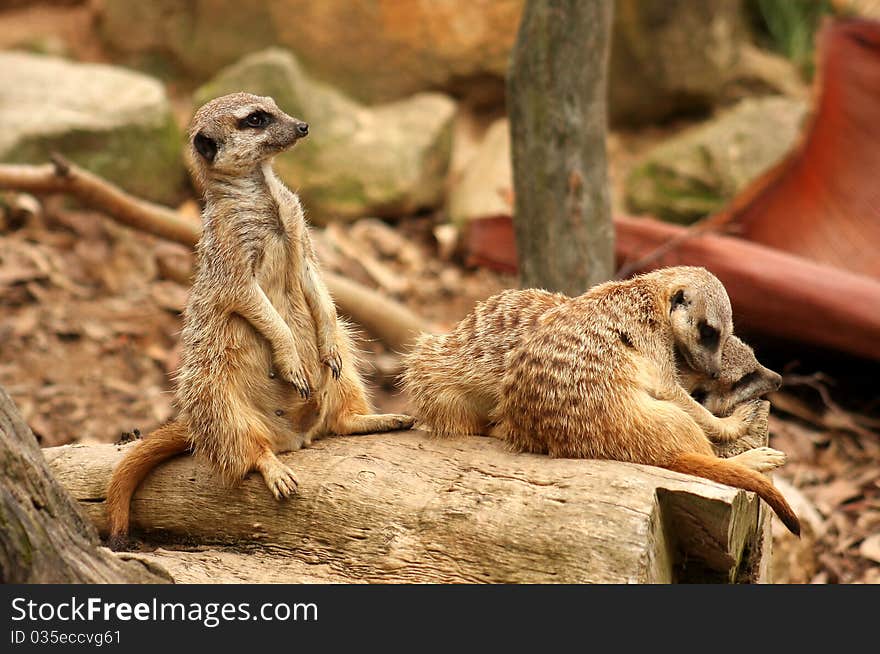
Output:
left=679, top=336, right=782, bottom=416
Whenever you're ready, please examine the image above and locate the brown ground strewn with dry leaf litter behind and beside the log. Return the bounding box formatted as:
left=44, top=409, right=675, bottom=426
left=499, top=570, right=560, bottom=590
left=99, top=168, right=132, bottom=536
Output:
left=0, top=198, right=880, bottom=583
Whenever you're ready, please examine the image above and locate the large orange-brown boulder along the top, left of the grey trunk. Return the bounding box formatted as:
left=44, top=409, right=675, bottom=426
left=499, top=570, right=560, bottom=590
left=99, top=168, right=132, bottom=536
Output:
left=98, top=0, right=523, bottom=102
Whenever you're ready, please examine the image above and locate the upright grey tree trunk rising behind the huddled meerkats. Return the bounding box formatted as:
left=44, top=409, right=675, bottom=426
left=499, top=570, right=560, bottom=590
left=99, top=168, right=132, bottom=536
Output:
left=507, top=0, right=614, bottom=296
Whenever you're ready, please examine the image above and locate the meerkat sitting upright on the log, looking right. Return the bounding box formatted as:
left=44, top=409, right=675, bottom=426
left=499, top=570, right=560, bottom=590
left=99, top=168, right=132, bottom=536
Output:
left=107, top=93, right=413, bottom=546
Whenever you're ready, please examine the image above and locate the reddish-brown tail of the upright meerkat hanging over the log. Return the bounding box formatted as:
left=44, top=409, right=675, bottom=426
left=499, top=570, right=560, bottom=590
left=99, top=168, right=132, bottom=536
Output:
left=107, top=421, right=190, bottom=550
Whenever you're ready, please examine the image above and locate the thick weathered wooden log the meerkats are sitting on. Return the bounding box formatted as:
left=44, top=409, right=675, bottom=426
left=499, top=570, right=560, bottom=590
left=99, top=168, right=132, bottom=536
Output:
left=44, top=431, right=764, bottom=583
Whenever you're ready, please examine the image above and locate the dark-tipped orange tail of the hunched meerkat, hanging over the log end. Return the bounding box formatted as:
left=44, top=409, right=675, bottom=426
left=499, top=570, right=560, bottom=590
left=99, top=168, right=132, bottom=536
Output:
left=663, top=453, right=801, bottom=536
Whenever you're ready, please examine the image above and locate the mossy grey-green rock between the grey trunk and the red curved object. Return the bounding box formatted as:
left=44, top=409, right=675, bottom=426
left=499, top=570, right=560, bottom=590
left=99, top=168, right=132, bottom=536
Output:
left=625, top=97, right=807, bottom=223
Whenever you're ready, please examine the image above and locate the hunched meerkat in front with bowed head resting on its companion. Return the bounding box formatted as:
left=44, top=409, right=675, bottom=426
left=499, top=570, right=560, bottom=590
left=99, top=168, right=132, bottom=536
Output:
left=491, top=267, right=800, bottom=534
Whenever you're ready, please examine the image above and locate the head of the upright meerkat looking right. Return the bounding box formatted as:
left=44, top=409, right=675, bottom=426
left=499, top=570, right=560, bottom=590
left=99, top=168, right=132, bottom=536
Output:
left=189, top=93, right=309, bottom=178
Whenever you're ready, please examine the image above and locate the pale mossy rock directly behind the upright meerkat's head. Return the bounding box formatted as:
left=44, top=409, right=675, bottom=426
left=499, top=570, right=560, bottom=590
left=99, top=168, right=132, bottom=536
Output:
left=196, top=48, right=455, bottom=223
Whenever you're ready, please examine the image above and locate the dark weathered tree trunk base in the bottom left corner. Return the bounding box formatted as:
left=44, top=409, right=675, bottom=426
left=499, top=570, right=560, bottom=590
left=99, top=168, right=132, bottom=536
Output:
left=0, top=387, right=170, bottom=584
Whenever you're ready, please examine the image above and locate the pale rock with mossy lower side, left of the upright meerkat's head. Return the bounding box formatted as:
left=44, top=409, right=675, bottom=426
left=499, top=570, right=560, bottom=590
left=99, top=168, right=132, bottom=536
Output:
left=0, top=52, right=186, bottom=203
